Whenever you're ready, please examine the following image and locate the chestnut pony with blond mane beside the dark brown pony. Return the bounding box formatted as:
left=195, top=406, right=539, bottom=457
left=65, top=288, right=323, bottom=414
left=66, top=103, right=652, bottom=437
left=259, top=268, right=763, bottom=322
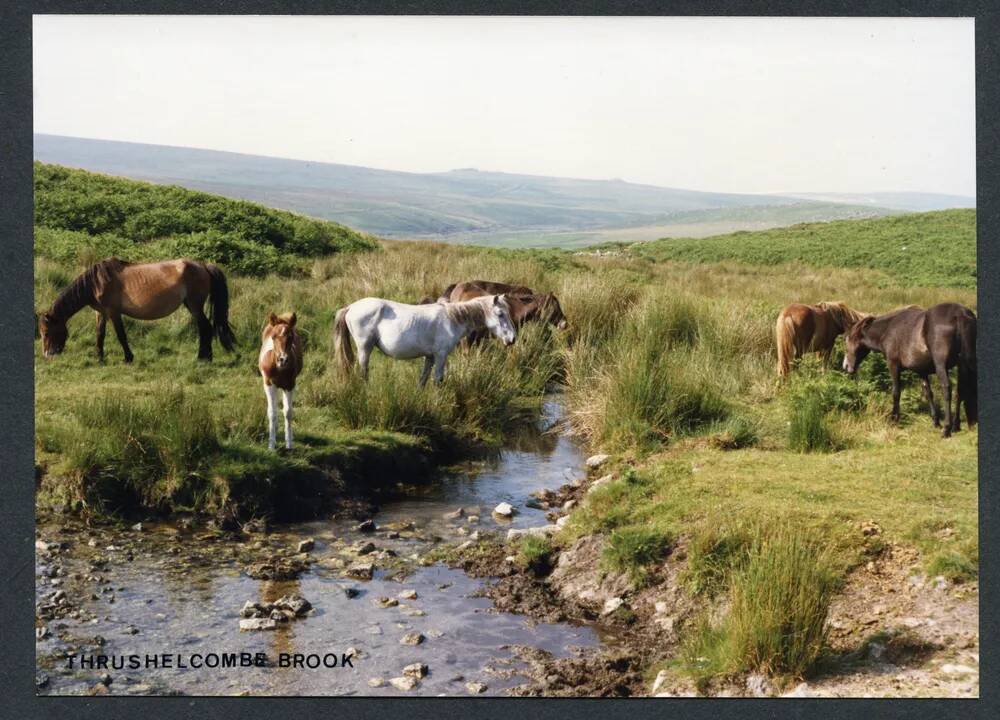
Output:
left=774, top=302, right=867, bottom=377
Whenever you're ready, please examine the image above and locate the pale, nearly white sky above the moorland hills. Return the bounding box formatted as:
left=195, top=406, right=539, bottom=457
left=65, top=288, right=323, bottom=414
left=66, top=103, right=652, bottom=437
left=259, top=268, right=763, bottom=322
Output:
left=33, top=16, right=975, bottom=196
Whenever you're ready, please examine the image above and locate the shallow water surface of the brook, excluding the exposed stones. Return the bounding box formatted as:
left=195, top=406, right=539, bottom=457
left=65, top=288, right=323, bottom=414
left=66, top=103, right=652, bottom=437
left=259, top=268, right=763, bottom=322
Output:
left=36, top=402, right=599, bottom=695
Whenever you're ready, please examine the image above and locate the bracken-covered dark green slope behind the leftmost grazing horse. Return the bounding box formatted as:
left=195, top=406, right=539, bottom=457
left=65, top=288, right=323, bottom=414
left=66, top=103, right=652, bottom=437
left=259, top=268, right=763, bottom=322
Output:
left=34, top=161, right=377, bottom=275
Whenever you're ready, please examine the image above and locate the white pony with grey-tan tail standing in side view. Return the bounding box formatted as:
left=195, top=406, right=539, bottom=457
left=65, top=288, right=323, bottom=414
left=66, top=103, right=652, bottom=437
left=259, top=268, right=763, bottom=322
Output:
left=333, top=295, right=517, bottom=387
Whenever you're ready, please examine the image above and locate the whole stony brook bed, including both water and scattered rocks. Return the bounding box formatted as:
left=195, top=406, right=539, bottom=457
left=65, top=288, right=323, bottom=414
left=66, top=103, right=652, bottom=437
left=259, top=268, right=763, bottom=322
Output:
left=36, top=396, right=624, bottom=695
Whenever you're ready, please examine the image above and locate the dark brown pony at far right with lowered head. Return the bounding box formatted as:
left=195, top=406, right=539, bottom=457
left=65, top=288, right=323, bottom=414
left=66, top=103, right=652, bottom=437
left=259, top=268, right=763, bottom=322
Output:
left=844, top=303, right=979, bottom=437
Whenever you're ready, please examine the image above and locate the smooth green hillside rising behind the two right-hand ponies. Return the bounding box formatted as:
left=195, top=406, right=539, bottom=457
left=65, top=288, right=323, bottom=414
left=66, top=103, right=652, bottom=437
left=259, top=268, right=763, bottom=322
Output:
left=615, top=209, right=976, bottom=288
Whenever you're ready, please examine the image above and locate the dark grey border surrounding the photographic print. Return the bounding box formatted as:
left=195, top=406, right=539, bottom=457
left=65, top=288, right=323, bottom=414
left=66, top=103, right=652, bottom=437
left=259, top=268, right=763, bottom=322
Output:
left=0, top=0, right=1000, bottom=720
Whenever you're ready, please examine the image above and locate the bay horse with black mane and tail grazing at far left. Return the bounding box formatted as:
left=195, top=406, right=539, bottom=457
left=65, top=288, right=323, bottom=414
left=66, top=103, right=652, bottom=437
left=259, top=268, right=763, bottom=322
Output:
left=38, top=258, right=234, bottom=363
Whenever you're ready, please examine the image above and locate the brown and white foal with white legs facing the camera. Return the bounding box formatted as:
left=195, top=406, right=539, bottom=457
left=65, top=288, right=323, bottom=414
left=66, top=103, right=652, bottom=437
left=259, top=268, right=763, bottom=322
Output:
left=257, top=313, right=302, bottom=450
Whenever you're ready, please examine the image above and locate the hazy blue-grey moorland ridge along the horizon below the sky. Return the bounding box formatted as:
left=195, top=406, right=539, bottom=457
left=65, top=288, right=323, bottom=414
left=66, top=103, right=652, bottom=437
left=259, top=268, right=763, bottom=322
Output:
left=35, top=134, right=924, bottom=246
